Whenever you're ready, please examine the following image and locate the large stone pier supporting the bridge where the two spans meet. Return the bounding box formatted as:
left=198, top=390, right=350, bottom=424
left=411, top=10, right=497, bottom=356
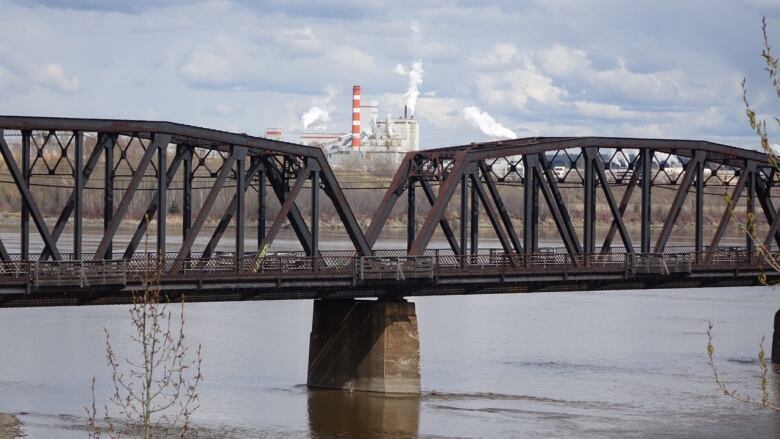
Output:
left=306, top=299, right=420, bottom=394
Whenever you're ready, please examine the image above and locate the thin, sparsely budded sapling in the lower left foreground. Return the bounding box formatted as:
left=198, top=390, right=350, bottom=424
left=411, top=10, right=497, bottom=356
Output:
left=86, top=229, right=203, bottom=439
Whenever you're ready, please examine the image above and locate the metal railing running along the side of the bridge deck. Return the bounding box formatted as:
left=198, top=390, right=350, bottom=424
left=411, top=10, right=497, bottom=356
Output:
left=0, top=247, right=768, bottom=288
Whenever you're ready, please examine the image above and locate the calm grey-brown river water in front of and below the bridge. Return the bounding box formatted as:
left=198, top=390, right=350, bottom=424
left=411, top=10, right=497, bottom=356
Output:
left=0, top=229, right=780, bottom=438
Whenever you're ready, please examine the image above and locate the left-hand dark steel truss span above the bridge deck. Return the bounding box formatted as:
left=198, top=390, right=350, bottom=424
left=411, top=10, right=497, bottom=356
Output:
left=0, top=116, right=371, bottom=264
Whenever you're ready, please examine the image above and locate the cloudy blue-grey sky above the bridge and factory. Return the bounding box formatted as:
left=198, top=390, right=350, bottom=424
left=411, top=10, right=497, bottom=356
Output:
left=0, top=0, right=780, bottom=148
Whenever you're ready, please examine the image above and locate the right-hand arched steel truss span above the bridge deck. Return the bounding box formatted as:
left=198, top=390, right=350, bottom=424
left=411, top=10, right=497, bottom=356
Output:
left=366, top=137, right=780, bottom=260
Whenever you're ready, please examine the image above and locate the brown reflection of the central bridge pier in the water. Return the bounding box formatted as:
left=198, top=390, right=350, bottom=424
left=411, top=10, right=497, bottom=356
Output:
left=308, top=390, right=420, bottom=439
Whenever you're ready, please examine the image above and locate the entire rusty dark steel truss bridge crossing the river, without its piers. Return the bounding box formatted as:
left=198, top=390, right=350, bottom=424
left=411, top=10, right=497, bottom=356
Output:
left=0, top=116, right=780, bottom=307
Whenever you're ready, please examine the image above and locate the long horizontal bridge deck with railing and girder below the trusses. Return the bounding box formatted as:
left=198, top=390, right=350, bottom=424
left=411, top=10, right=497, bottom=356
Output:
left=0, top=248, right=780, bottom=307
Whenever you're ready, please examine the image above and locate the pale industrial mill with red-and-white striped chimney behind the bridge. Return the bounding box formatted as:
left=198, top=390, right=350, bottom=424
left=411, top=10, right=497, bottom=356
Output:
left=300, top=85, right=420, bottom=173
